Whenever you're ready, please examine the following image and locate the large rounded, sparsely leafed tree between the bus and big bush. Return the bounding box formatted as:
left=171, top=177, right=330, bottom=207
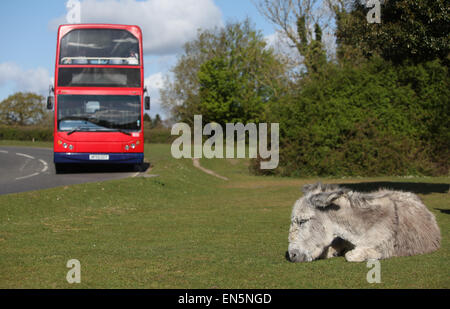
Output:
left=161, top=20, right=284, bottom=123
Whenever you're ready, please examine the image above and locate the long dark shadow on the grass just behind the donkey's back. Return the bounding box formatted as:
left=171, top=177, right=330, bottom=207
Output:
left=340, top=181, right=450, bottom=194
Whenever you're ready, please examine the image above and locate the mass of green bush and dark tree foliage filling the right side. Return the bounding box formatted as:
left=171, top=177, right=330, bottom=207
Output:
left=252, top=0, right=450, bottom=176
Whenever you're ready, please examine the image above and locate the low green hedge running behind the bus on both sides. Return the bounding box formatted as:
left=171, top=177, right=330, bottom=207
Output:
left=0, top=126, right=176, bottom=144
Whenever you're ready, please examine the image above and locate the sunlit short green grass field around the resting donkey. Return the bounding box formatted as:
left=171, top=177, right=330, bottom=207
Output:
left=0, top=142, right=450, bottom=289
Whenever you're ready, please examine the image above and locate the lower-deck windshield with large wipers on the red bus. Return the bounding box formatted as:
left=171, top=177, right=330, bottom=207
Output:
left=58, top=95, right=141, bottom=132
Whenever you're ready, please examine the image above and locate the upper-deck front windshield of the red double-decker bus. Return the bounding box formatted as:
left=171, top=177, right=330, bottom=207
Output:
left=59, top=29, right=139, bottom=65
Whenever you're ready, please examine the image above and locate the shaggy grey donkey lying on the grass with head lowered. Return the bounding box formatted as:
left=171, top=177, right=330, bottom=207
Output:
left=288, top=183, right=441, bottom=262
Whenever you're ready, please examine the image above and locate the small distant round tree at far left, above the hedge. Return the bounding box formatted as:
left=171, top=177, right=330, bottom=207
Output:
left=0, top=92, right=47, bottom=126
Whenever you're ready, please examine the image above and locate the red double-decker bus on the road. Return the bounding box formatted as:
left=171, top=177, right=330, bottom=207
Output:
left=47, top=24, right=150, bottom=171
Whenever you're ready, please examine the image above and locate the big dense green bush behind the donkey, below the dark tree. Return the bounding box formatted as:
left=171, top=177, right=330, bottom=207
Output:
left=252, top=58, right=450, bottom=176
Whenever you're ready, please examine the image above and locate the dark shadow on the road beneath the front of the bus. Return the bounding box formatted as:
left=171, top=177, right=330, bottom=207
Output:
left=57, top=162, right=150, bottom=174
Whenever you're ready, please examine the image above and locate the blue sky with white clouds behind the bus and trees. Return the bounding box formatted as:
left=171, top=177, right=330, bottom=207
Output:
left=0, top=0, right=275, bottom=116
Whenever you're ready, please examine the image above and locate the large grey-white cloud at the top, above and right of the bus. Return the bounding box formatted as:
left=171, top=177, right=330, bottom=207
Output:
left=49, top=0, right=223, bottom=55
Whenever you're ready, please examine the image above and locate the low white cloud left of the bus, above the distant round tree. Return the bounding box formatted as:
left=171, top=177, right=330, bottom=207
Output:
left=0, top=62, right=53, bottom=95
